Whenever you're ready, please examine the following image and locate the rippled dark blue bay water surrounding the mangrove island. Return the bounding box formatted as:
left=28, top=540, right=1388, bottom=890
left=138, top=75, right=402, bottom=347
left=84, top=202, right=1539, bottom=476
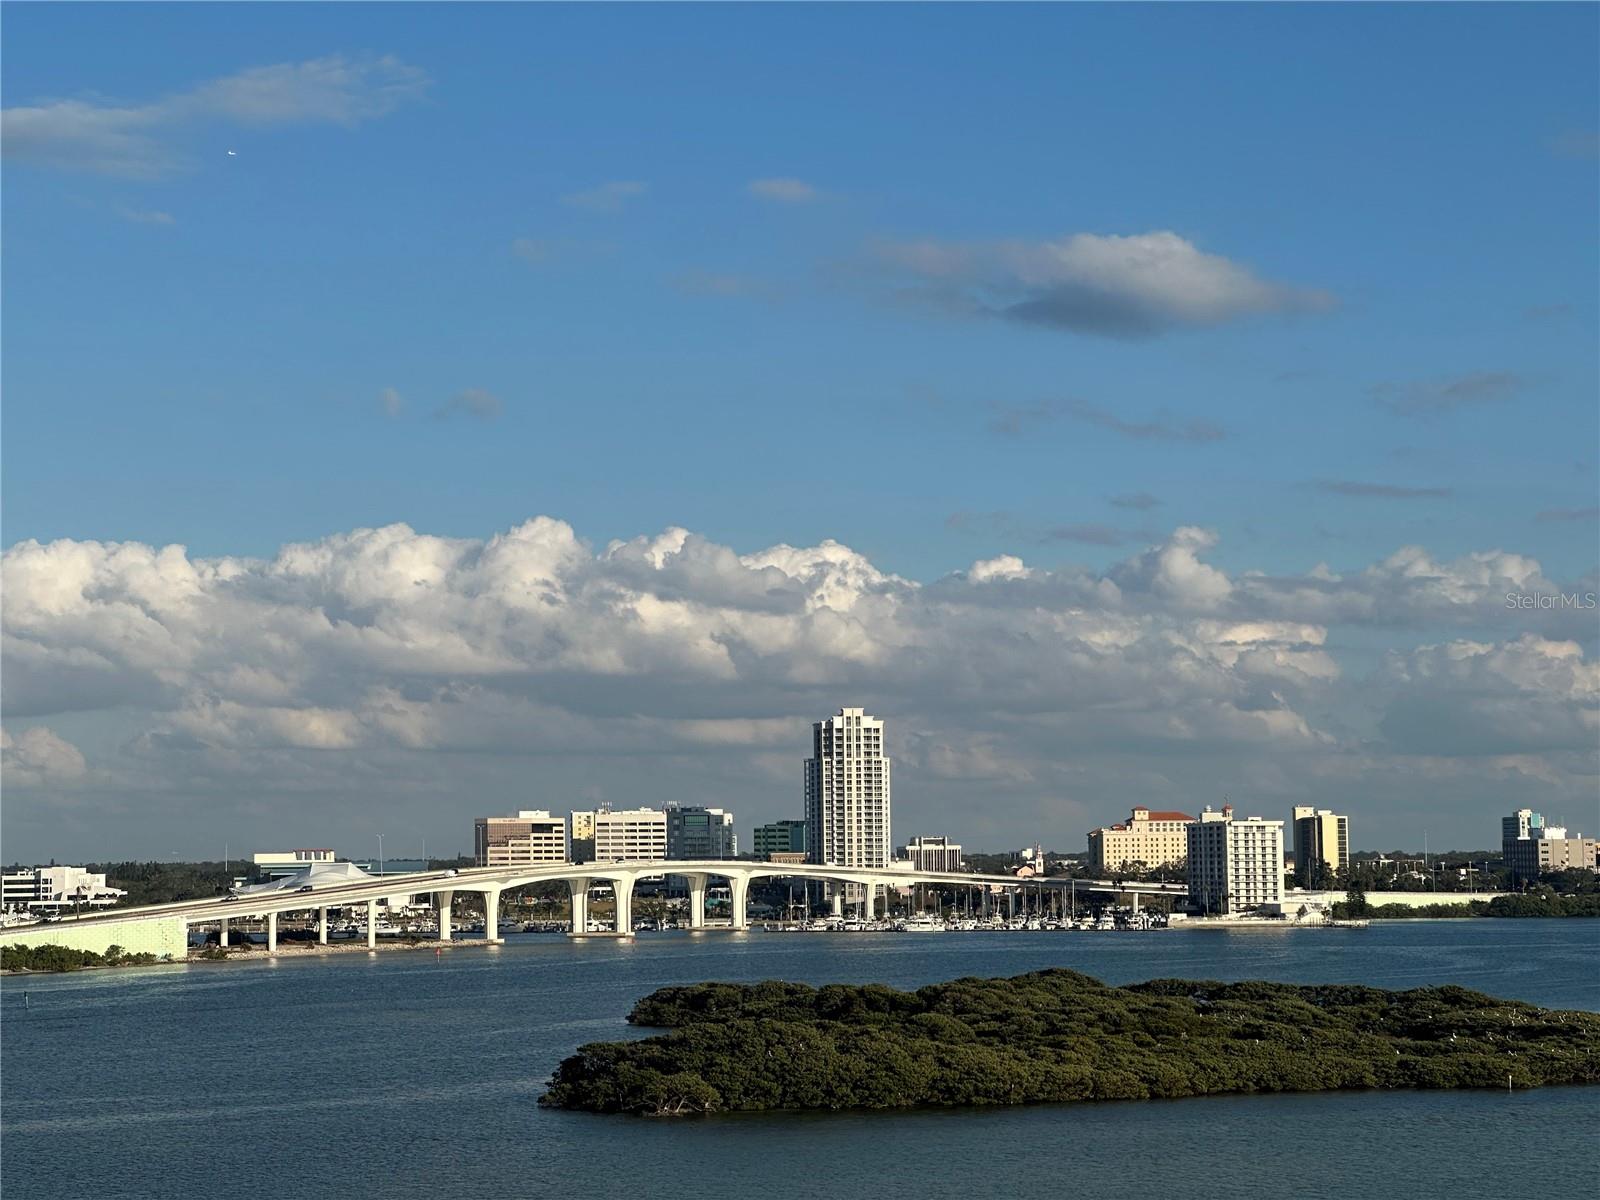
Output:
left=0, top=920, right=1600, bottom=1200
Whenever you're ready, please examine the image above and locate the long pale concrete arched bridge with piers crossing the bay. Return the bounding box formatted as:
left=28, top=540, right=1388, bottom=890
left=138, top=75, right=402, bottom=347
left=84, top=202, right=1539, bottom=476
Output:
left=0, top=859, right=1187, bottom=952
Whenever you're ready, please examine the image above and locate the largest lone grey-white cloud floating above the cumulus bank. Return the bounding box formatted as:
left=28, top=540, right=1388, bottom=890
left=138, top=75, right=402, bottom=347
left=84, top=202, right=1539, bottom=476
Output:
left=875, top=230, right=1333, bottom=338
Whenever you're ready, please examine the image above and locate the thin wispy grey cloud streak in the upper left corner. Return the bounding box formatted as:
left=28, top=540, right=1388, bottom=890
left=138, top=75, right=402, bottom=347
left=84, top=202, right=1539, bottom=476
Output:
left=0, top=54, right=429, bottom=179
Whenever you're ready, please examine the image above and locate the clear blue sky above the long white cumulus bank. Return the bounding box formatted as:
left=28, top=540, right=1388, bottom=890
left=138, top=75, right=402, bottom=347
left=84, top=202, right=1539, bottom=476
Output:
left=3, top=5, right=1600, bottom=842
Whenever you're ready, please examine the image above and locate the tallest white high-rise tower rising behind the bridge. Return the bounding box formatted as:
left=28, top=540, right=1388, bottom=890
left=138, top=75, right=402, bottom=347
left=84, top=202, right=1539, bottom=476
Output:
left=805, top=709, right=893, bottom=867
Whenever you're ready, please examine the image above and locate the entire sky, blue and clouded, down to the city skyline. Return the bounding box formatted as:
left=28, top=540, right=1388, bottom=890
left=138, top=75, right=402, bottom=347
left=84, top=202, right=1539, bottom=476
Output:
left=0, top=5, right=1600, bottom=861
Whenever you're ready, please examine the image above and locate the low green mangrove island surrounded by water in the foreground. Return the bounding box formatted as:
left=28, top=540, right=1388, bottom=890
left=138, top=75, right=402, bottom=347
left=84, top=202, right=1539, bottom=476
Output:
left=539, top=970, right=1600, bottom=1115
